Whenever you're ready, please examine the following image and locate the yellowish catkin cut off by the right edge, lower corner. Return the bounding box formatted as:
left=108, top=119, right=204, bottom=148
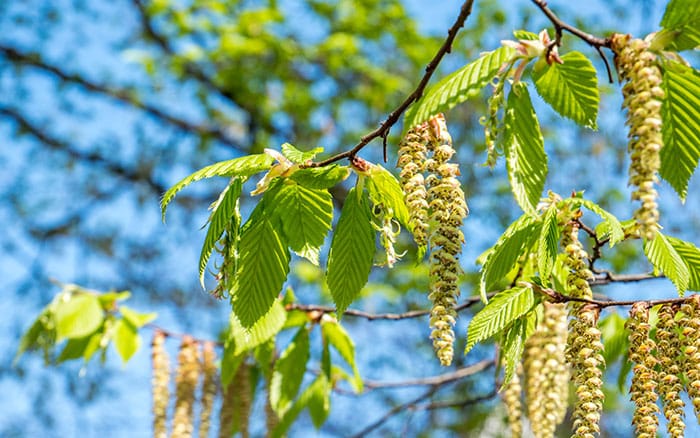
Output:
left=679, top=295, right=700, bottom=423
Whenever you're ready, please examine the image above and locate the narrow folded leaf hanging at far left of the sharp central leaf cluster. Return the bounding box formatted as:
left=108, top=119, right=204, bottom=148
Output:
left=199, top=178, right=243, bottom=289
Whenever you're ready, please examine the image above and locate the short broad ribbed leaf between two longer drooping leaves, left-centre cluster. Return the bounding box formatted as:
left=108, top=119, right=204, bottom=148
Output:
left=270, top=182, right=333, bottom=265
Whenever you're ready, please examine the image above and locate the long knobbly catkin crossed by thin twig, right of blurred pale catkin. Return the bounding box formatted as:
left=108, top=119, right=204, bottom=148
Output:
left=562, top=219, right=605, bottom=437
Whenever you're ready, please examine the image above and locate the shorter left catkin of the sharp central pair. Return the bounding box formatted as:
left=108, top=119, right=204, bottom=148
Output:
left=397, top=123, right=433, bottom=246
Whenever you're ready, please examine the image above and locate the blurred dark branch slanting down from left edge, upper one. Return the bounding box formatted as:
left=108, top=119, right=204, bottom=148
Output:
left=0, top=46, right=239, bottom=148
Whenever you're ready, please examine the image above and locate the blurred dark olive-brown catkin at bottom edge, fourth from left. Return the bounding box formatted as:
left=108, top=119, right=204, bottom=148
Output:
left=219, top=362, right=253, bottom=438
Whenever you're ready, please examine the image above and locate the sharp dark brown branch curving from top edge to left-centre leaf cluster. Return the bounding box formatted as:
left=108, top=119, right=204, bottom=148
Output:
left=310, top=0, right=474, bottom=167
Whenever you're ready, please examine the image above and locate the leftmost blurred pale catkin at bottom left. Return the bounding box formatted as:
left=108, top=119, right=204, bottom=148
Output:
left=151, top=330, right=170, bottom=438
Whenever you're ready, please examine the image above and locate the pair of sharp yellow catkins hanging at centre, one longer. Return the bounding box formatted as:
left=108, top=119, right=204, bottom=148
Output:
left=399, top=114, right=468, bottom=366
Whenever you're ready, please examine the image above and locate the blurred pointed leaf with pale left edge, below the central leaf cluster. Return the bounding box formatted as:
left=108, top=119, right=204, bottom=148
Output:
left=270, top=327, right=311, bottom=417
